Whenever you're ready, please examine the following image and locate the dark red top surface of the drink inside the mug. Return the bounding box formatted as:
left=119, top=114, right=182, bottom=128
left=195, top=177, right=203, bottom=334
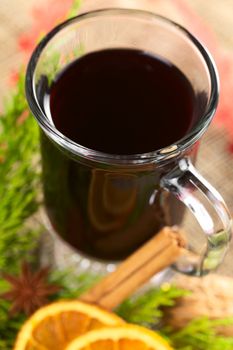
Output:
left=50, top=49, right=194, bottom=155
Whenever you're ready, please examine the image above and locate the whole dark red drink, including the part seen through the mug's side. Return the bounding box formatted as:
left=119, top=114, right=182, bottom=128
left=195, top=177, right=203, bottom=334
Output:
left=41, top=49, right=197, bottom=260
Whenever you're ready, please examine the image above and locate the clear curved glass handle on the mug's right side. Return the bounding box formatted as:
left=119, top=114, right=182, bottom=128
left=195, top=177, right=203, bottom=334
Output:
left=160, top=158, right=231, bottom=276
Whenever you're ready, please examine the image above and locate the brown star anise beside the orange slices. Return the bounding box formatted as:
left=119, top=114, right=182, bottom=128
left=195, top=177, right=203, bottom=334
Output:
left=0, top=262, right=60, bottom=315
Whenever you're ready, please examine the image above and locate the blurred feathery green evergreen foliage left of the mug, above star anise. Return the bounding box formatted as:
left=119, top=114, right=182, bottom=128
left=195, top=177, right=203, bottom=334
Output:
left=0, top=73, right=39, bottom=272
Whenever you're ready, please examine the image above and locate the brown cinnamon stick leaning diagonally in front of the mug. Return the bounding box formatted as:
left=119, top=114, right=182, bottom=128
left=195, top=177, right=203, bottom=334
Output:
left=80, top=227, right=185, bottom=310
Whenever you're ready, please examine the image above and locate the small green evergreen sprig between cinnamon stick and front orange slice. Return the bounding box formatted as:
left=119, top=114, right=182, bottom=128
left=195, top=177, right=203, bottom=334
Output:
left=116, top=283, right=188, bottom=326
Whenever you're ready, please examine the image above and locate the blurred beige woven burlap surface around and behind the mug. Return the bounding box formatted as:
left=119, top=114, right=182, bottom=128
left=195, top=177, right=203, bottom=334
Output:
left=0, top=0, right=233, bottom=275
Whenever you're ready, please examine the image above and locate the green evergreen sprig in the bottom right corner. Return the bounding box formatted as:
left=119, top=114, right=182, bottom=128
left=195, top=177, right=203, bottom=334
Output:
left=166, top=317, right=233, bottom=350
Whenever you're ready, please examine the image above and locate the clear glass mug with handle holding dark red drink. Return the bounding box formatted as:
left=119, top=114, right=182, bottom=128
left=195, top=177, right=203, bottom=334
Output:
left=26, top=9, right=231, bottom=275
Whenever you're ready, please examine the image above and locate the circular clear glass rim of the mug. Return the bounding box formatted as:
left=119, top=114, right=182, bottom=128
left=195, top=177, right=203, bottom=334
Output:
left=25, top=8, right=219, bottom=165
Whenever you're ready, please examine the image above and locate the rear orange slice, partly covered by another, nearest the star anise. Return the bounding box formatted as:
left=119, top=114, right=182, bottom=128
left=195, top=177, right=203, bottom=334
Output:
left=14, top=300, right=124, bottom=350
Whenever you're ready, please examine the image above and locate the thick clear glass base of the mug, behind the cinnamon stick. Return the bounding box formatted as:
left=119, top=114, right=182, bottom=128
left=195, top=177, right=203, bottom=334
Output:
left=40, top=210, right=174, bottom=289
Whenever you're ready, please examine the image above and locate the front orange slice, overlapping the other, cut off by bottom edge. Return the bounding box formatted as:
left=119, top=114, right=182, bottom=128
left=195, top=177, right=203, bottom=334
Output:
left=65, top=325, right=172, bottom=350
